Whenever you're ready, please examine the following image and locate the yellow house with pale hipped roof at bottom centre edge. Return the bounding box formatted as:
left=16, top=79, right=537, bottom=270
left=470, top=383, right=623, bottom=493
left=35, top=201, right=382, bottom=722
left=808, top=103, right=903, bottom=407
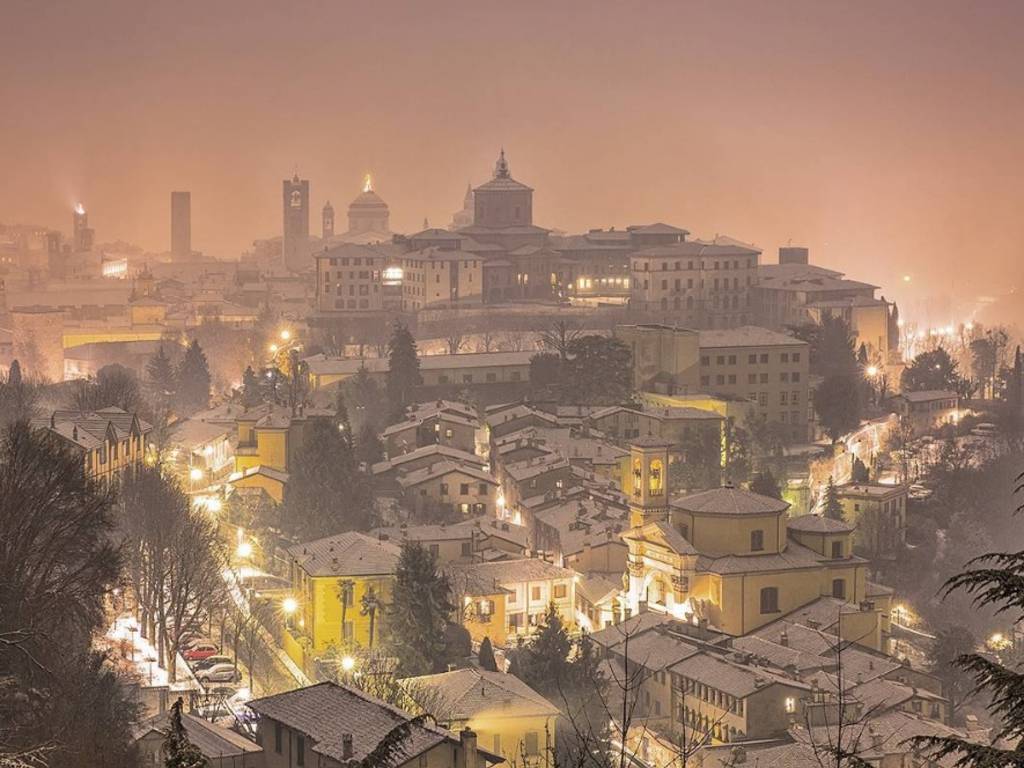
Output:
left=404, top=667, right=559, bottom=766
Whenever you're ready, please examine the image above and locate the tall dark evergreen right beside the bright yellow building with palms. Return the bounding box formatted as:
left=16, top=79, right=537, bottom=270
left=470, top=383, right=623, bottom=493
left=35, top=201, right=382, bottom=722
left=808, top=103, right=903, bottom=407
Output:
left=387, top=542, right=455, bottom=676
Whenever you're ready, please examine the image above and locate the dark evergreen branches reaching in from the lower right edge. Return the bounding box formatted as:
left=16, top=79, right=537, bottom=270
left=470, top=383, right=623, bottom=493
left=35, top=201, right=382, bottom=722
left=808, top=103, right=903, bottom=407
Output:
left=913, top=474, right=1024, bottom=768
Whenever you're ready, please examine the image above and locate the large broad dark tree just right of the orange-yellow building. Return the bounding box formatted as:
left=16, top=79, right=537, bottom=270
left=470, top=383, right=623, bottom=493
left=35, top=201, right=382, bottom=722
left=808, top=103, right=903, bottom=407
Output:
left=282, top=418, right=373, bottom=541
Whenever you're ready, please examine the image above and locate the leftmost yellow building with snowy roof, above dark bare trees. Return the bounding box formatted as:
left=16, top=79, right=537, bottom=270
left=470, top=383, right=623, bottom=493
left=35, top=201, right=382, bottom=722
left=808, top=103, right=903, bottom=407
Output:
left=32, top=408, right=153, bottom=483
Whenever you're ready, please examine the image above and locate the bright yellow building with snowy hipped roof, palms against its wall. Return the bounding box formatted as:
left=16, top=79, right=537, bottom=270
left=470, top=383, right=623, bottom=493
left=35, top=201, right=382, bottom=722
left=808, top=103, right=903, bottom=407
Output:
left=285, top=531, right=400, bottom=665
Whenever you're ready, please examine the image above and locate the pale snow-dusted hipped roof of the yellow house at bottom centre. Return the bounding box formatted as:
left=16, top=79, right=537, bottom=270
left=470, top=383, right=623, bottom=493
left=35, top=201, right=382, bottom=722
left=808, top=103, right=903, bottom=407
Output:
left=403, top=667, right=558, bottom=720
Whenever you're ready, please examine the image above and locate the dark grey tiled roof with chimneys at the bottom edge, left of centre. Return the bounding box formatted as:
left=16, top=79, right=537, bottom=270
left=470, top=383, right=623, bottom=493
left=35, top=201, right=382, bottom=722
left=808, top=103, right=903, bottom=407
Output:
left=249, top=683, right=455, bottom=762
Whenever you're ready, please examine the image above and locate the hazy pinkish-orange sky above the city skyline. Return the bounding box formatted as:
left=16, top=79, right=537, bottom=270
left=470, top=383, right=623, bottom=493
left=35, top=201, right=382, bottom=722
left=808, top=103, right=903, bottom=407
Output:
left=0, top=0, right=1024, bottom=313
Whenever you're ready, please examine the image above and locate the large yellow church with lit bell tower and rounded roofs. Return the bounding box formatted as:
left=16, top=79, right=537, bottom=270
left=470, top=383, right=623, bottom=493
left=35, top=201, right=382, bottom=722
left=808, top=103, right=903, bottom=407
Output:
left=623, top=438, right=884, bottom=649
